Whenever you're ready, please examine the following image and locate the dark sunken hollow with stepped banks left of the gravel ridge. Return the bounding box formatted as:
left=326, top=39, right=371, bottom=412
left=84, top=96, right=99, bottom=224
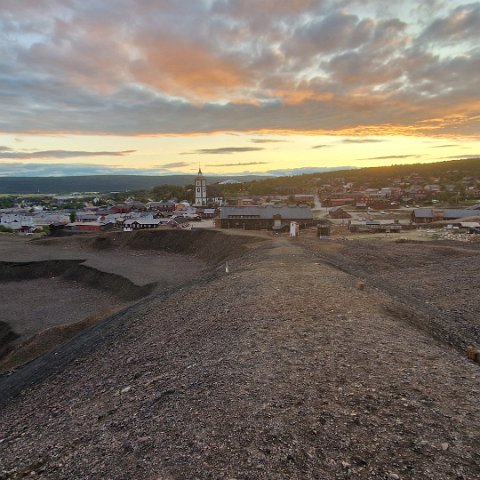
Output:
left=0, top=232, right=219, bottom=373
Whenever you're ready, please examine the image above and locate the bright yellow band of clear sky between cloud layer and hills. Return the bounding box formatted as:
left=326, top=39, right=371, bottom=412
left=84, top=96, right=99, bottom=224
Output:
left=0, top=133, right=480, bottom=176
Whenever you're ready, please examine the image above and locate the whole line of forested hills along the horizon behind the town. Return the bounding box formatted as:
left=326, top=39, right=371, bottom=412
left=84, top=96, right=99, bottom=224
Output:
left=0, top=158, right=480, bottom=195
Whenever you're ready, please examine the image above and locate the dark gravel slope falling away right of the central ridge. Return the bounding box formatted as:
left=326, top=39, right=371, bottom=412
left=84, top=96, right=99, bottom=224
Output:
left=305, top=240, right=480, bottom=352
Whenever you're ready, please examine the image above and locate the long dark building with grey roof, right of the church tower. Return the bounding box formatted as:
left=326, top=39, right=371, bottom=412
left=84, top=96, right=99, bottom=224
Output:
left=220, top=205, right=314, bottom=231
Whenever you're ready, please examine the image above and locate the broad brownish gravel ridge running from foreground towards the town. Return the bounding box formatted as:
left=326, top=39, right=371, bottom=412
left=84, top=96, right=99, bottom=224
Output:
left=0, top=237, right=480, bottom=480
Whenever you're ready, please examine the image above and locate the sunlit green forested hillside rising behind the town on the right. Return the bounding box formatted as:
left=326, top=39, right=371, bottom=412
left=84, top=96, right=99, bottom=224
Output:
left=222, top=157, right=480, bottom=195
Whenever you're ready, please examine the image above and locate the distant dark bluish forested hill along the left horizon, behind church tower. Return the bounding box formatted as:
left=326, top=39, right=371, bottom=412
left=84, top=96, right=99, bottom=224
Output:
left=0, top=175, right=264, bottom=194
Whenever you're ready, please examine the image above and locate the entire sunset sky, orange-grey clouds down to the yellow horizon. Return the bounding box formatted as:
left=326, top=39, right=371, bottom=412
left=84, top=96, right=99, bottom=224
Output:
left=0, top=0, right=480, bottom=176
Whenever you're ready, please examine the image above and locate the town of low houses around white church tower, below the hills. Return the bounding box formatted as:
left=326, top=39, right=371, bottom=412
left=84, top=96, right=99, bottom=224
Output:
left=0, top=160, right=480, bottom=235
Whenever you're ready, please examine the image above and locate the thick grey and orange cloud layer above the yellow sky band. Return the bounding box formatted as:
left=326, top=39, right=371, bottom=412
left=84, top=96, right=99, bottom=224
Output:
left=0, top=0, right=480, bottom=141
